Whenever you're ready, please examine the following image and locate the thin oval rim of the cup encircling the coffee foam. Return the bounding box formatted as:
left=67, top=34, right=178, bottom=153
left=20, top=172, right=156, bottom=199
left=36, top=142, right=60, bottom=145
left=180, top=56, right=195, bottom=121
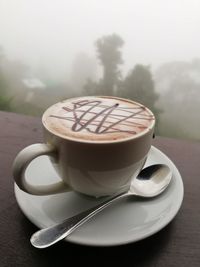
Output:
left=42, top=95, right=156, bottom=145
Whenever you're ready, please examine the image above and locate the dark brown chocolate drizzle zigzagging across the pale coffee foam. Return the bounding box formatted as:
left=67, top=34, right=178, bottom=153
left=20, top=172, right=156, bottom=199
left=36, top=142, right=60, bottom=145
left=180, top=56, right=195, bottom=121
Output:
left=50, top=100, right=154, bottom=134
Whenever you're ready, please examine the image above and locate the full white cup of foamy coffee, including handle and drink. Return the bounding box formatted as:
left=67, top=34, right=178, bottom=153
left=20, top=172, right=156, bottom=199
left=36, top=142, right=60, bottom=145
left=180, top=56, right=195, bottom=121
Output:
left=13, top=96, right=155, bottom=197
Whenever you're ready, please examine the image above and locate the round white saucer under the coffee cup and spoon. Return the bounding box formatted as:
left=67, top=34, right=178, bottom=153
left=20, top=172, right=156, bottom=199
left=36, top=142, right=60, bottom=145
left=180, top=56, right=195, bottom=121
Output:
left=15, top=147, right=183, bottom=246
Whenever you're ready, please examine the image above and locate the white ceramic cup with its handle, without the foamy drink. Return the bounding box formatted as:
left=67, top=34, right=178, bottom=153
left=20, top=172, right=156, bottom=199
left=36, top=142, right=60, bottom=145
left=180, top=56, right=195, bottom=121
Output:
left=13, top=98, right=155, bottom=197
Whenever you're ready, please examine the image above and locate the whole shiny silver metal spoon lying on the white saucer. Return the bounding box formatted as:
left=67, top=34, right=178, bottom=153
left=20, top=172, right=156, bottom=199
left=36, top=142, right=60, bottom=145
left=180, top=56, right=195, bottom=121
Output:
left=30, top=164, right=172, bottom=248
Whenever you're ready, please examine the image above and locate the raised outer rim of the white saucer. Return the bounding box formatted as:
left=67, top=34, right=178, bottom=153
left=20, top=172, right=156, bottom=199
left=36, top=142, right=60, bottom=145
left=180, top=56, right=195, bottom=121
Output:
left=14, top=146, right=184, bottom=247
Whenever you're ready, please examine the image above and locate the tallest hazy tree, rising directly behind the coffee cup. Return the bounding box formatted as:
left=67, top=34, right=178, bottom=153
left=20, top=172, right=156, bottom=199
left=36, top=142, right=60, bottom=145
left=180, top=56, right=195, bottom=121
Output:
left=95, top=34, right=124, bottom=95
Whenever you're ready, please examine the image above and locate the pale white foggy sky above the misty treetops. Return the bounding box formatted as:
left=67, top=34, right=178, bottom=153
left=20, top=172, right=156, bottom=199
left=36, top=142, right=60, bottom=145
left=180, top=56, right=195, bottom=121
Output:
left=0, top=0, right=200, bottom=80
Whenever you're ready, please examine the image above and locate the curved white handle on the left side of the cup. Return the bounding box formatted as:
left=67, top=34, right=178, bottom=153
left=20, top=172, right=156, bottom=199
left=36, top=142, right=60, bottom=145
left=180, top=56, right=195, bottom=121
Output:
left=13, top=144, right=72, bottom=195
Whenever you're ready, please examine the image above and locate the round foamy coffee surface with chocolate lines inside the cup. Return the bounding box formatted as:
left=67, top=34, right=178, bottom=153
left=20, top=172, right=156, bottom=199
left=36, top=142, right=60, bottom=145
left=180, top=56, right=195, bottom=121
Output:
left=43, top=96, right=155, bottom=141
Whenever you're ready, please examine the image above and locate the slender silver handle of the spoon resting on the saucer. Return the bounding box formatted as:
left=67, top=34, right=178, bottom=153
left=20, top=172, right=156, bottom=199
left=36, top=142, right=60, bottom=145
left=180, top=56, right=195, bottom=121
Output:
left=30, top=192, right=129, bottom=248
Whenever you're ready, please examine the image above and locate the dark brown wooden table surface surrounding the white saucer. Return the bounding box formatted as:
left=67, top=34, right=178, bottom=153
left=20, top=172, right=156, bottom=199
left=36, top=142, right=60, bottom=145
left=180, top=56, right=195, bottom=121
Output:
left=0, top=112, right=200, bottom=267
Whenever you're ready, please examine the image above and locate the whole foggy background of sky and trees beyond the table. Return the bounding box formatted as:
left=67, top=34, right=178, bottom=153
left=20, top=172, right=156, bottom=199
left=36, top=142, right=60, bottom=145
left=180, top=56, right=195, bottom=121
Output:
left=0, top=0, right=200, bottom=141
